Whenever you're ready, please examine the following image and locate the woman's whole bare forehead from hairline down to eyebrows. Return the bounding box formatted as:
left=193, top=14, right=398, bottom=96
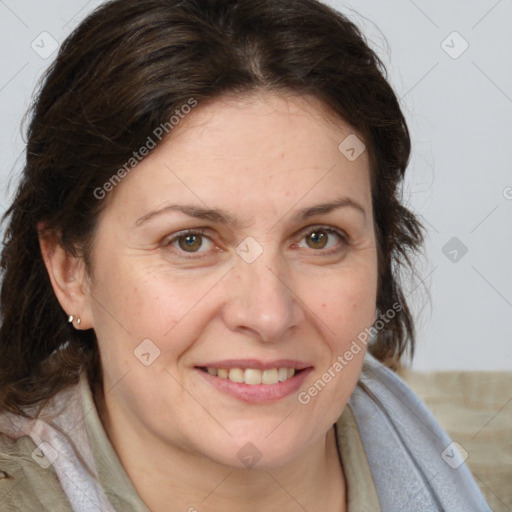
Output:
left=102, top=94, right=370, bottom=226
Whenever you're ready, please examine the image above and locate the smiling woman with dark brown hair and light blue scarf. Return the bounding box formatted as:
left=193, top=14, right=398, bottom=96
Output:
left=0, top=0, right=489, bottom=512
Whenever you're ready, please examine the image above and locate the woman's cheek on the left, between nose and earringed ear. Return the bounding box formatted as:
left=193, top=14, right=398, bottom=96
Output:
left=91, top=258, right=222, bottom=360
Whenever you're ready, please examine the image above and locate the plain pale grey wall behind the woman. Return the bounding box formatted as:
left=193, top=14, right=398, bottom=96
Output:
left=0, top=0, right=512, bottom=370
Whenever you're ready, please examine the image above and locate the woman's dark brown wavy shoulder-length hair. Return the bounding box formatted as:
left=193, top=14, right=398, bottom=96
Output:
left=0, top=0, right=423, bottom=414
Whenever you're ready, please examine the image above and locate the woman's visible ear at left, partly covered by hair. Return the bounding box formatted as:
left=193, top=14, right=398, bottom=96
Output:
left=38, top=223, right=92, bottom=330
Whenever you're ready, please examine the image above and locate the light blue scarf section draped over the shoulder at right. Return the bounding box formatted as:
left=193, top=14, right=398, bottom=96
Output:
left=349, top=353, right=492, bottom=512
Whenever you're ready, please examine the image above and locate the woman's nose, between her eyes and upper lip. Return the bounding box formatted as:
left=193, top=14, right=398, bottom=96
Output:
left=223, top=248, right=303, bottom=343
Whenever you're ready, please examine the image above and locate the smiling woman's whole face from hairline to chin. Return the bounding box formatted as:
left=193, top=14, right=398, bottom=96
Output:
left=84, top=94, right=377, bottom=468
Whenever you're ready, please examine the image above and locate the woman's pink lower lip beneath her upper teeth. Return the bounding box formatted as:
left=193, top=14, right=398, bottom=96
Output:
left=195, top=368, right=313, bottom=404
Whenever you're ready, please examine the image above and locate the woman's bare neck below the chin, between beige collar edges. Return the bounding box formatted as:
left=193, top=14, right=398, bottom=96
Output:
left=96, top=388, right=346, bottom=512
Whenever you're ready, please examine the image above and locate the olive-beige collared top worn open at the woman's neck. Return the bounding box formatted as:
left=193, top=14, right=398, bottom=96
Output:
left=0, top=378, right=380, bottom=512
